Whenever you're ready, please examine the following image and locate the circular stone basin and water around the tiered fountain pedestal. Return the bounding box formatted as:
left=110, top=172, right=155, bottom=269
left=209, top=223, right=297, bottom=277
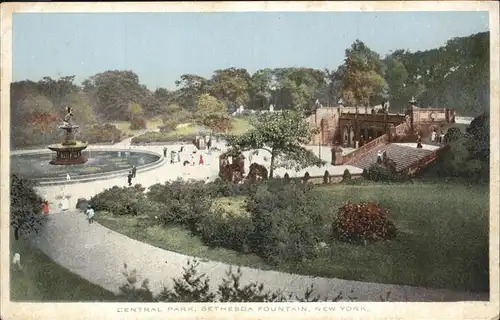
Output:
left=10, top=150, right=161, bottom=181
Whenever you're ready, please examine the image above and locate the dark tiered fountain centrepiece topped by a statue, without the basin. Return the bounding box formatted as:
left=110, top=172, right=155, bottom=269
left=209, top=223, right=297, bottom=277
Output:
left=48, top=107, right=87, bottom=165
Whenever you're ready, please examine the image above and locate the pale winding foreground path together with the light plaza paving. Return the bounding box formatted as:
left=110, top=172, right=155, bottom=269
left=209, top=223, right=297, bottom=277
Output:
left=24, top=131, right=488, bottom=301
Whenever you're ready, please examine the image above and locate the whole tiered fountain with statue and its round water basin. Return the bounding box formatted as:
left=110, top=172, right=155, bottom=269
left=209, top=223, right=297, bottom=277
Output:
left=10, top=107, right=164, bottom=186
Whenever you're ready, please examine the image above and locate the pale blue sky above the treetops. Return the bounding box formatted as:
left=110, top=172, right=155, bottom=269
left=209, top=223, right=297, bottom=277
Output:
left=12, top=12, right=488, bottom=89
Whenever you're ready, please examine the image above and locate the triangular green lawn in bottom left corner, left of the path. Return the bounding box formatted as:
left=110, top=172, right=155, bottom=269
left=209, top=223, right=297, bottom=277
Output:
left=10, top=239, right=118, bottom=302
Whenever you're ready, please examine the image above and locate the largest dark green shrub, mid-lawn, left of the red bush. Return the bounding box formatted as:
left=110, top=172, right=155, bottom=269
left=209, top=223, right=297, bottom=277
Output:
left=247, top=183, right=320, bottom=263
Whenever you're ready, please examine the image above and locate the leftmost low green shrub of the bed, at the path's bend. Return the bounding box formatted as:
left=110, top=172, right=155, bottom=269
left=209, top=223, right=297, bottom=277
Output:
left=89, top=185, right=145, bottom=215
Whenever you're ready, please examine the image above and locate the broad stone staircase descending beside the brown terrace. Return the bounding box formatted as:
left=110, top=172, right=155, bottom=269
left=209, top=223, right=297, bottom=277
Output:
left=349, top=143, right=433, bottom=172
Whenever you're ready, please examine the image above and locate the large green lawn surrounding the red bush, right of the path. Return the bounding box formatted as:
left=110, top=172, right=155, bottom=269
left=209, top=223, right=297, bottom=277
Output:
left=97, top=182, right=489, bottom=291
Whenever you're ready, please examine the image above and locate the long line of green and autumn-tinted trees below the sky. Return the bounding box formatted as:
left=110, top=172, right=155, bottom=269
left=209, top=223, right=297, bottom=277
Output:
left=11, top=32, right=489, bottom=146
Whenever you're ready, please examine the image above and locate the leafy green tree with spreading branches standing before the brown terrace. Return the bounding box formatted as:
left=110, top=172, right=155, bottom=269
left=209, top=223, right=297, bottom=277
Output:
left=226, top=108, right=324, bottom=178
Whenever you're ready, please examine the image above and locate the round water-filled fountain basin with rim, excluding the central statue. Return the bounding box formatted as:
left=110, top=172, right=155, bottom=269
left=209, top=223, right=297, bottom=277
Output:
left=10, top=149, right=164, bottom=185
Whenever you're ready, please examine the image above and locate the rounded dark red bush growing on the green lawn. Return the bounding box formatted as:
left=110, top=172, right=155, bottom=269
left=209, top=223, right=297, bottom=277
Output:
left=333, top=202, right=396, bottom=243
